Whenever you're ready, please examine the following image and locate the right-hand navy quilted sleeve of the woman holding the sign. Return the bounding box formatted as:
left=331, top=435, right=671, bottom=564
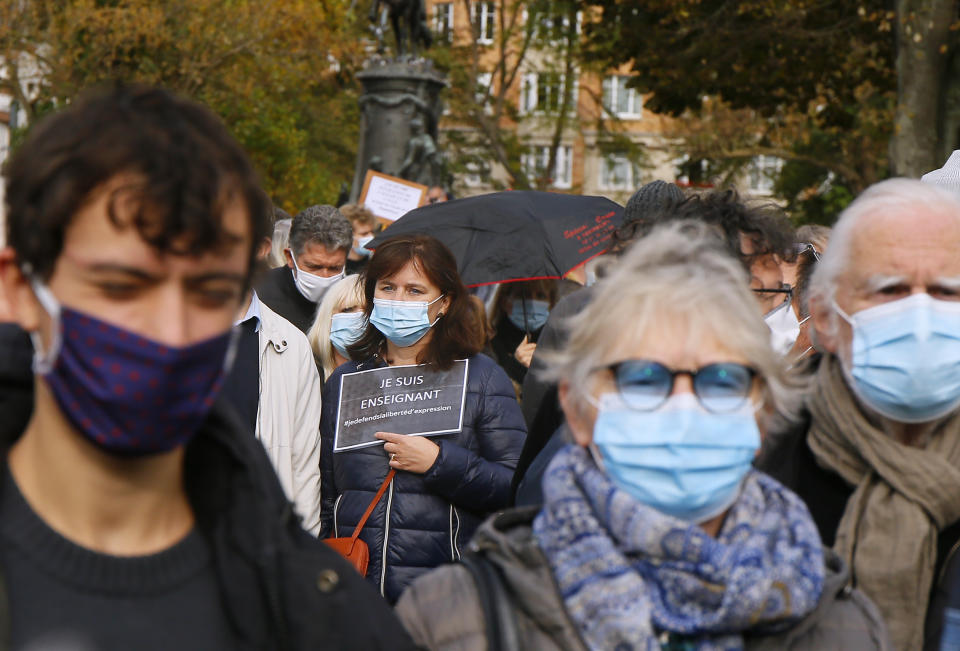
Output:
left=423, top=355, right=527, bottom=512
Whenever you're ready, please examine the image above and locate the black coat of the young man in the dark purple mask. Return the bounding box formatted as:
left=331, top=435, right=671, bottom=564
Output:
left=0, top=364, right=414, bottom=651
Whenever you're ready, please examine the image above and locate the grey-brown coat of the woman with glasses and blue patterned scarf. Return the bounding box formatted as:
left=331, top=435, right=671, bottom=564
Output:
left=397, top=508, right=890, bottom=651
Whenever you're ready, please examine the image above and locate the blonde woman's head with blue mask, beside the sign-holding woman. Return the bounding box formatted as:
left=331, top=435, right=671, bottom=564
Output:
left=307, top=274, right=367, bottom=380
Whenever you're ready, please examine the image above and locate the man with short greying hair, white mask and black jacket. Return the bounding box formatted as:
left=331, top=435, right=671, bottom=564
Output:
left=257, top=206, right=353, bottom=334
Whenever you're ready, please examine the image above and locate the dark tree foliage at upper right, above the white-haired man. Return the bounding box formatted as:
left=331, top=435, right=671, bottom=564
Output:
left=583, top=0, right=957, bottom=220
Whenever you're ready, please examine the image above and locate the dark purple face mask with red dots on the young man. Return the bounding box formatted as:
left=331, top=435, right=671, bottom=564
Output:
left=31, top=280, right=239, bottom=456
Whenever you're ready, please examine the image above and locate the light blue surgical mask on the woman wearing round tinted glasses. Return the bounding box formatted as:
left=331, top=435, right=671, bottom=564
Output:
left=591, top=393, right=760, bottom=523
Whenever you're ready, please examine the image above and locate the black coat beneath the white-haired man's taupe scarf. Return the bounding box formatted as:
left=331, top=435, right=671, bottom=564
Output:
left=754, top=414, right=960, bottom=649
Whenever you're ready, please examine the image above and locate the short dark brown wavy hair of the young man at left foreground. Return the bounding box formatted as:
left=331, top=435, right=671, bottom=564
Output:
left=6, top=84, right=271, bottom=279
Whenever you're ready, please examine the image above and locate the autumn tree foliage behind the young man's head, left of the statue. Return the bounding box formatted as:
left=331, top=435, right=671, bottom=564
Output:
left=0, top=0, right=362, bottom=212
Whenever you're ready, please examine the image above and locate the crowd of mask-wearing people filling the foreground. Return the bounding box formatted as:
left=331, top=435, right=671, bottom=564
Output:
left=0, top=86, right=960, bottom=651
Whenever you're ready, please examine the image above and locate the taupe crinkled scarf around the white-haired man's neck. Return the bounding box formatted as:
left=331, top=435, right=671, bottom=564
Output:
left=807, top=355, right=960, bottom=649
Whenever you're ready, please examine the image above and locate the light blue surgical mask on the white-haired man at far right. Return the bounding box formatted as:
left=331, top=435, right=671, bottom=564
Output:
left=834, top=294, right=960, bottom=423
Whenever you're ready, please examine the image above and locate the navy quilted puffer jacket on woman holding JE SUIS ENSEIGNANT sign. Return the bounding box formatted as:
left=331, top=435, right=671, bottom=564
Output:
left=320, top=355, right=526, bottom=603
